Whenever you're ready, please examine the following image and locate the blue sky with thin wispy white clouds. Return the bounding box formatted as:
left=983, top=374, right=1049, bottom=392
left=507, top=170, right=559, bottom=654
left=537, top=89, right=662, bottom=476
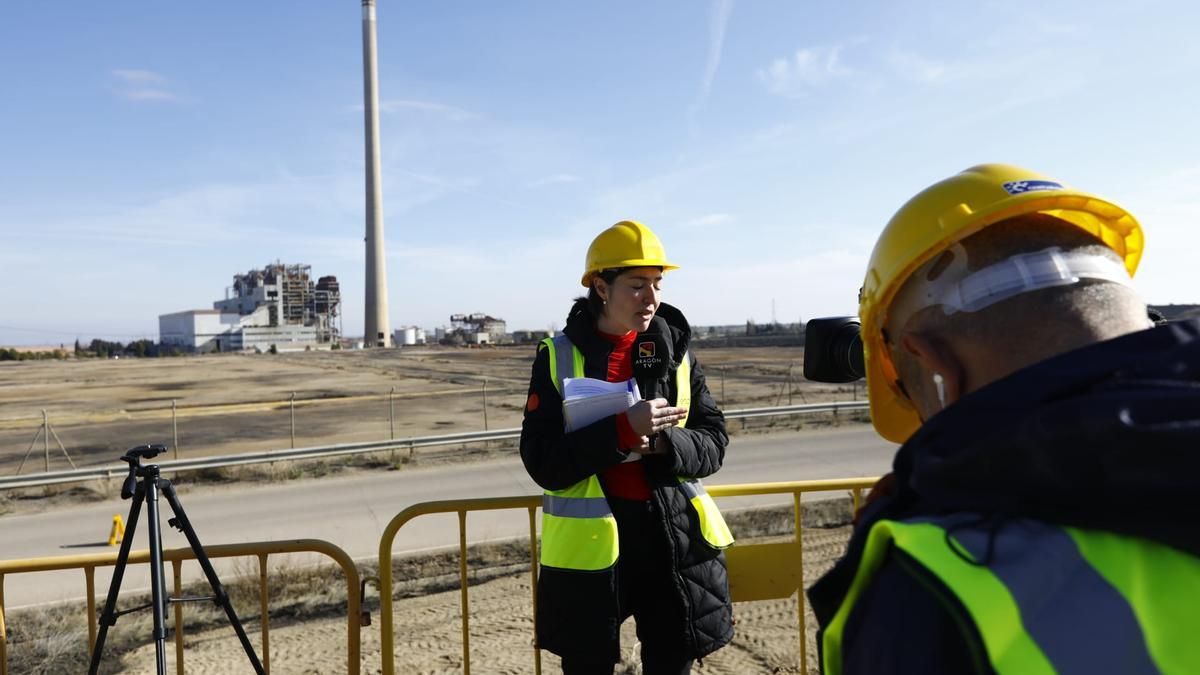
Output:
left=0, top=0, right=1200, bottom=344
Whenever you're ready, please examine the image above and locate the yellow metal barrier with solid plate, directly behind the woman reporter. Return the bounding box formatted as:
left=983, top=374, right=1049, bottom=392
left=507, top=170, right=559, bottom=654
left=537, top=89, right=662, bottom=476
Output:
left=379, top=478, right=877, bottom=675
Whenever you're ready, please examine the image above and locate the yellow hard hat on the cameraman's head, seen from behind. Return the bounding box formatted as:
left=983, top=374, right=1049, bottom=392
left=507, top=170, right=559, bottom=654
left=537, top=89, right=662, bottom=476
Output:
left=858, top=165, right=1144, bottom=443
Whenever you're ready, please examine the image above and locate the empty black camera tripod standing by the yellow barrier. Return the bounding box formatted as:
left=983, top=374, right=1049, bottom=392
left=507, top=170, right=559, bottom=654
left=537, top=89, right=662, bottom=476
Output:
left=88, top=446, right=264, bottom=675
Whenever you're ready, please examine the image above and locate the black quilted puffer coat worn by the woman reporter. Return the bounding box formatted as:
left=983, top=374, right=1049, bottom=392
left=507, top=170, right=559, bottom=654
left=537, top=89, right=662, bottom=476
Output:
left=521, top=301, right=733, bottom=662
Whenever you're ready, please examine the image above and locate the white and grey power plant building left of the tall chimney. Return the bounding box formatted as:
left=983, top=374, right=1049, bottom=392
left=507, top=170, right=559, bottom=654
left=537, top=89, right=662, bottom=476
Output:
left=158, top=263, right=342, bottom=352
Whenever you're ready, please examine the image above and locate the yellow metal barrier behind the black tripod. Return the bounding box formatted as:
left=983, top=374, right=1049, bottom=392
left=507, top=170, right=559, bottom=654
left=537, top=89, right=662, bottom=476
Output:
left=0, top=539, right=361, bottom=675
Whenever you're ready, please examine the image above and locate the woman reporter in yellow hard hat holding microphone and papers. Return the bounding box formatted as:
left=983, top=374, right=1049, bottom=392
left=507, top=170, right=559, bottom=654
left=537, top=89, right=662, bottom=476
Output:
left=521, top=221, right=733, bottom=675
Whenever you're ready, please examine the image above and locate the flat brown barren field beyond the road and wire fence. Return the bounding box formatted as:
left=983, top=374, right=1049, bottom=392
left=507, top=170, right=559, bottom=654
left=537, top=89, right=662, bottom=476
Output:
left=0, top=345, right=863, bottom=473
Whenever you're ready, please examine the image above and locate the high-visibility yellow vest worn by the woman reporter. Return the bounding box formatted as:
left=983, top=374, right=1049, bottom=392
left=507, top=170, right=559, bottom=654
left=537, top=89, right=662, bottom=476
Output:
left=540, top=335, right=733, bottom=571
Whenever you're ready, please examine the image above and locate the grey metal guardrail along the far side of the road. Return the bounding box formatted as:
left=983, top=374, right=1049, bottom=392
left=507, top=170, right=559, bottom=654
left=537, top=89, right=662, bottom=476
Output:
left=0, top=401, right=868, bottom=490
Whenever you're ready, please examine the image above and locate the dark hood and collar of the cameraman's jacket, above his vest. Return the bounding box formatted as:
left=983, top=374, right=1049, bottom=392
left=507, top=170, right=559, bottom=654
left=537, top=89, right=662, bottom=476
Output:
left=808, top=319, right=1200, bottom=625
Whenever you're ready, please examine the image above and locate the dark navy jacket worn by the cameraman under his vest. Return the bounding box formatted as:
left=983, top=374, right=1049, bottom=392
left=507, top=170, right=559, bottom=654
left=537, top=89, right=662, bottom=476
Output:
left=809, top=321, right=1200, bottom=675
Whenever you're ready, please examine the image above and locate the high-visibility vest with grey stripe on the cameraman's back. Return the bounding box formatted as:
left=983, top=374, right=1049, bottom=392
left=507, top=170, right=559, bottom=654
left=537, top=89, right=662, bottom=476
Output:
left=822, top=514, right=1200, bottom=675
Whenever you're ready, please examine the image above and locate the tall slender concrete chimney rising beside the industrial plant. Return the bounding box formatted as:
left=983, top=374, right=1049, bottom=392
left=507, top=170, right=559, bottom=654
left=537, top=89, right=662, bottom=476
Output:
left=362, top=0, right=391, bottom=347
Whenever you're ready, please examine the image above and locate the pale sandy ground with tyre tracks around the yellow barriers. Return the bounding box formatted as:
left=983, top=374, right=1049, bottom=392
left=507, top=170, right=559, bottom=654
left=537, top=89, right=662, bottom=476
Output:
left=110, top=516, right=850, bottom=675
